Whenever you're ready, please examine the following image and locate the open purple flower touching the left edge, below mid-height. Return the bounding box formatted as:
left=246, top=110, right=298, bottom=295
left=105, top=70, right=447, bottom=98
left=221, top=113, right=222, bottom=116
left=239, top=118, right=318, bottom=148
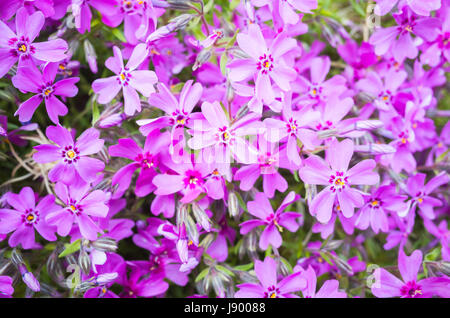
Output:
left=0, top=187, right=58, bottom=249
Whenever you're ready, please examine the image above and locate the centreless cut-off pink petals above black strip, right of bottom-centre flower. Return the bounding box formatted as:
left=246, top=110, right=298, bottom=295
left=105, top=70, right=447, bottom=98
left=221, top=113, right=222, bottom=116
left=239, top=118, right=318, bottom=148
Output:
left=299, top=265, right=347, bottom=298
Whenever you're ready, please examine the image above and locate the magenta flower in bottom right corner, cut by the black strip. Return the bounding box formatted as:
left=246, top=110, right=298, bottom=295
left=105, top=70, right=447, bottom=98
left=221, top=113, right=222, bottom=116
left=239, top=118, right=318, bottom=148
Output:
left=371, top=249, right=450, bottom=298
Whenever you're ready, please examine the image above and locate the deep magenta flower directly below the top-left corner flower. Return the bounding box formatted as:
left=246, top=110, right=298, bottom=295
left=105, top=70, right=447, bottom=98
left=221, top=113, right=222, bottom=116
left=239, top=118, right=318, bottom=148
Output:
left=12, top=63, right=80, bottom=124
